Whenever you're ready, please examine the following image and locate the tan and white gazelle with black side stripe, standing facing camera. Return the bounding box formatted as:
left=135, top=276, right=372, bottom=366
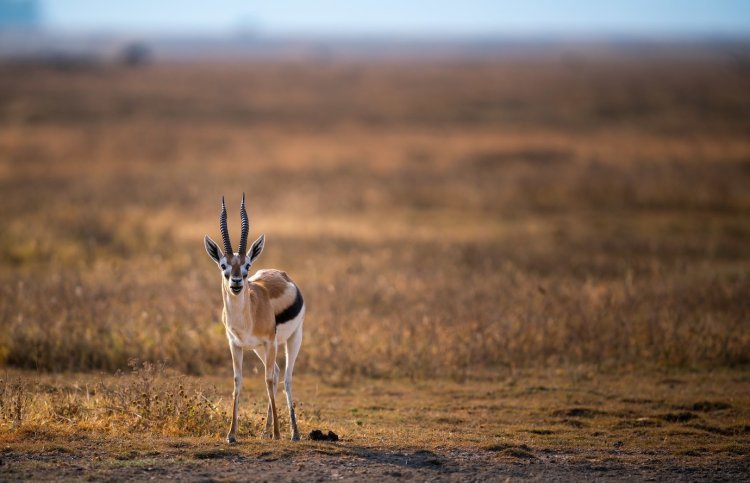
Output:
left=203, top=193, right=305, bottom=443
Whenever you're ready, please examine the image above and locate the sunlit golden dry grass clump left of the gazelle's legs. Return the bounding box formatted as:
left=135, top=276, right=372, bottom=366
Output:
left=0, top=361, right=228, bottom=436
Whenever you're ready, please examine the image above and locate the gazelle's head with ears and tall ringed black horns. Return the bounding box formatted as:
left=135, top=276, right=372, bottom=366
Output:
left=203, top=193, right=265, bottom=295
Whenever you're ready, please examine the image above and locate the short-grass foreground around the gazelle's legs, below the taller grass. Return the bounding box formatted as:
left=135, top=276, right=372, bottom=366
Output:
left=0, top=364, right=750, bottom=480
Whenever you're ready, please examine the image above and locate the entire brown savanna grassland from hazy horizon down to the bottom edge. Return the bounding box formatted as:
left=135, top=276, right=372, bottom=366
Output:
left=0, top=46, right=750, bottom=480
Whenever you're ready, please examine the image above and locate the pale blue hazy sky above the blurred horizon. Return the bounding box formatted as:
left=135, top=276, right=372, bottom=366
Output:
left=43, top=0, right=750, bottom=36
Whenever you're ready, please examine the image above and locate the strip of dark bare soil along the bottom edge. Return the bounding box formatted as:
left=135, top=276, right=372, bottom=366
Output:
left=0, top=441, right=750, bottom=481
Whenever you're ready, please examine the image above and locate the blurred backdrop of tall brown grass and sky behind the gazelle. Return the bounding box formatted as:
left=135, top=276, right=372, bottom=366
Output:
left=0, top=0, right=750, bottom=380
